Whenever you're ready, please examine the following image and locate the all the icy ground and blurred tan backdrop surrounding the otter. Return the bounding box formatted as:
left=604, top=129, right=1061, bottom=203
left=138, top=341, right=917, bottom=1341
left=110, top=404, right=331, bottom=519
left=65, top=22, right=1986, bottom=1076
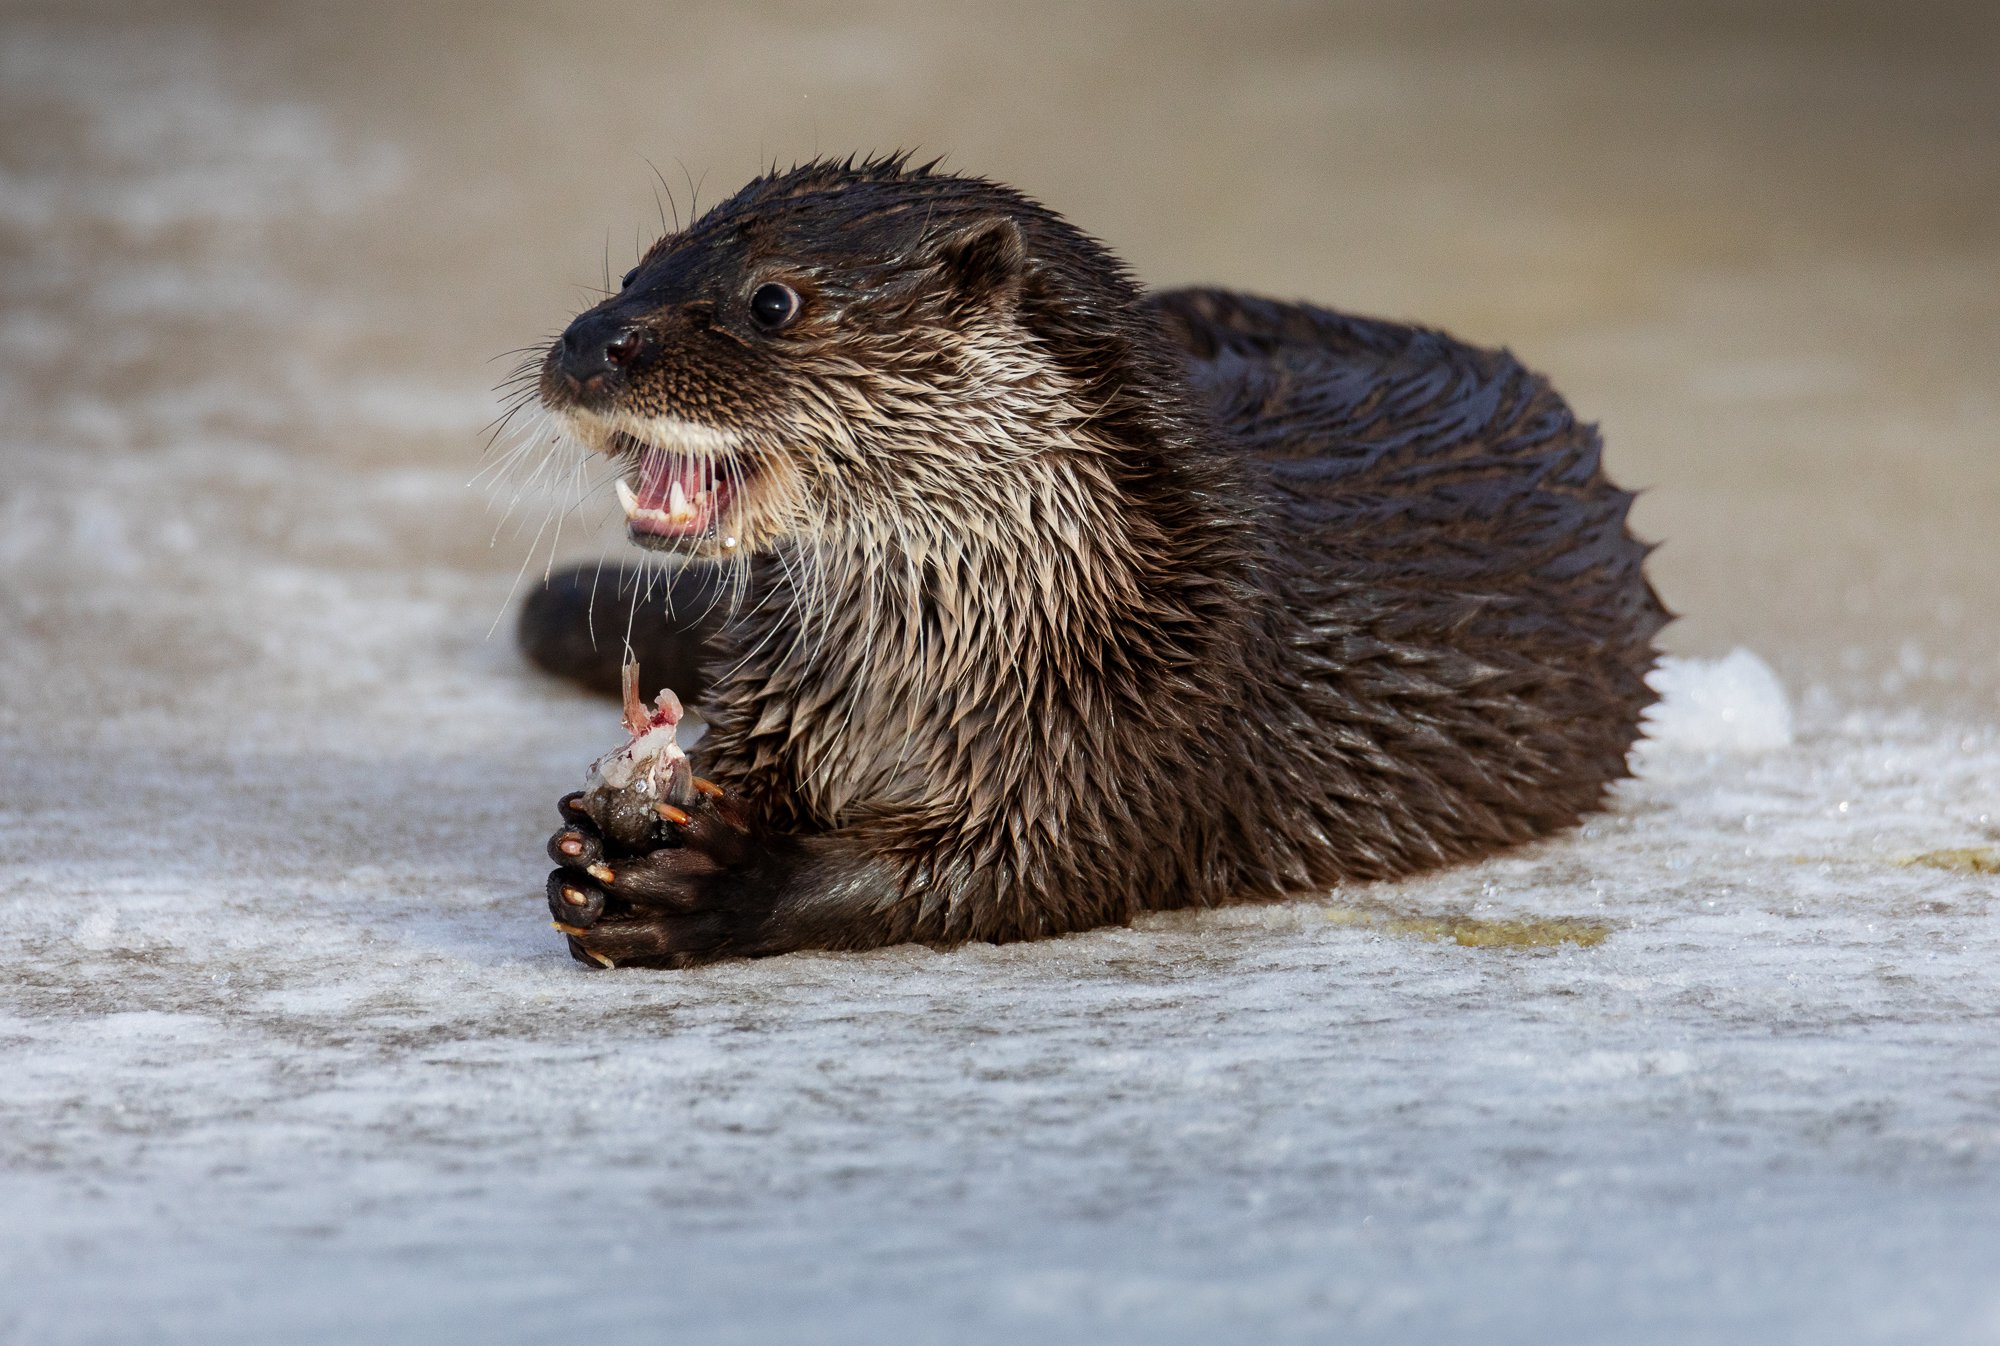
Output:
left=0, top=0, right=2000, bottom=1346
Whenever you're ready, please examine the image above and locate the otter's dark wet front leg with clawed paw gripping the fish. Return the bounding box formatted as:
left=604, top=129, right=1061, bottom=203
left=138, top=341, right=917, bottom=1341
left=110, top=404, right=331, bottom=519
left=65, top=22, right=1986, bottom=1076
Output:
left=548, top=794, right=912, bottom=968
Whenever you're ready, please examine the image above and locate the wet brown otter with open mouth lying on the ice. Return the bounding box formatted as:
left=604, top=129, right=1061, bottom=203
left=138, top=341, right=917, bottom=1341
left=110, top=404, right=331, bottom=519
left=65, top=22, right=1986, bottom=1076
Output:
left=522, top=156, right=1670, bottom=966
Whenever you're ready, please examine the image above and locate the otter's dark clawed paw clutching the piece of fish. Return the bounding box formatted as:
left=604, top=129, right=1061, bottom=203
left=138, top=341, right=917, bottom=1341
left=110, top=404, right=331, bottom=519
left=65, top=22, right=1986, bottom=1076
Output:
left=548, top=792, right=760, bottom=968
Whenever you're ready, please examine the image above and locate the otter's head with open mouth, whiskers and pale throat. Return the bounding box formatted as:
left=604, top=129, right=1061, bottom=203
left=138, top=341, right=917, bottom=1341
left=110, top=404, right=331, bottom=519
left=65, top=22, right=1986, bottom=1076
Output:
left=540, top=158, right=1138, bottom=560
